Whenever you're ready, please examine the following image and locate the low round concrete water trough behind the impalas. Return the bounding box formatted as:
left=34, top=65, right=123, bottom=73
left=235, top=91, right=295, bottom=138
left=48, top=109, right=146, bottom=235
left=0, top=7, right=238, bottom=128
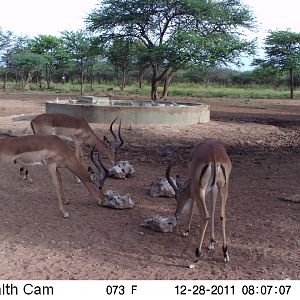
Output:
left=46, top=97, right=210, bottom=125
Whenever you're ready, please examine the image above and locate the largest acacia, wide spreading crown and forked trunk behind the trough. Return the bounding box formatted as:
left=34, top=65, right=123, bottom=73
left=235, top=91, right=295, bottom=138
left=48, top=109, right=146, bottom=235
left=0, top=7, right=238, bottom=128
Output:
left=86, top=0, right=254, bottom=100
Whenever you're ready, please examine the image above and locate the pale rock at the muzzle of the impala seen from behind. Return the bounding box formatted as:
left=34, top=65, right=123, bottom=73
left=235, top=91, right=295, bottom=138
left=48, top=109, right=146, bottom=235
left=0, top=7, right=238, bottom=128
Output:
left=141, top=215, right=176, bottom=232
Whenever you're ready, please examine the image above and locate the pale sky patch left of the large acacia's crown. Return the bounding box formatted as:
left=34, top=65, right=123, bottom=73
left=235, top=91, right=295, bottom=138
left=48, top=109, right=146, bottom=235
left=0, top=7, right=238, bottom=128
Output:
left=0, top=0, right=99, bottom=37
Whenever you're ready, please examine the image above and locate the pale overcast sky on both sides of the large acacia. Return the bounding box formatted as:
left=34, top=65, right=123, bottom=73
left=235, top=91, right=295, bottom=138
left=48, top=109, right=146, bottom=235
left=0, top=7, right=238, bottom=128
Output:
left=0, top=0, right=300, bottom=68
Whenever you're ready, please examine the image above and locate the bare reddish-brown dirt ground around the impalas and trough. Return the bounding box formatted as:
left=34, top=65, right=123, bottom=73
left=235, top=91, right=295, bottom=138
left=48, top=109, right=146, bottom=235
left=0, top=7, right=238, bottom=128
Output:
left=0, top=93, right=300, bottom=280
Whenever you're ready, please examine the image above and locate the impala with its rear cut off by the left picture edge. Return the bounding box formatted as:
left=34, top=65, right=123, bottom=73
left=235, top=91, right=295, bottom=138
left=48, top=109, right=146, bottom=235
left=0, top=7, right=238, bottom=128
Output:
left=0, top=135, right=107, bottom=218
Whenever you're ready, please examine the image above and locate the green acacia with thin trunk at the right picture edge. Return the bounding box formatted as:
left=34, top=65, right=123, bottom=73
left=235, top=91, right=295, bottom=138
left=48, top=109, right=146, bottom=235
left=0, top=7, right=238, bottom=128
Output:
left=254, top=30, right=300, bottom=98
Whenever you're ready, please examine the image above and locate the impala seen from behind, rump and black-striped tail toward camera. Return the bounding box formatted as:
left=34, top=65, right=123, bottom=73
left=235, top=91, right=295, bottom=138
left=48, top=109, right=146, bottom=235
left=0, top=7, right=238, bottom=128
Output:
left=166, top=139, right=231, bottom=263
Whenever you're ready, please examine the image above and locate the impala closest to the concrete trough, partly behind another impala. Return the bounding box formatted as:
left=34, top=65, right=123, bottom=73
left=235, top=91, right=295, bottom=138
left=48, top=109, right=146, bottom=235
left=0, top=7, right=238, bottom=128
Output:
left=30, top=113, right=124, bottom=164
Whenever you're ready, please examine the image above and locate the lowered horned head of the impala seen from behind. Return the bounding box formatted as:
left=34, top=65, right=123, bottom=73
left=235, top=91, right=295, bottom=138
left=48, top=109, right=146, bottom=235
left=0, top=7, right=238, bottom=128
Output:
left=166, top=162, right=191, bottom=220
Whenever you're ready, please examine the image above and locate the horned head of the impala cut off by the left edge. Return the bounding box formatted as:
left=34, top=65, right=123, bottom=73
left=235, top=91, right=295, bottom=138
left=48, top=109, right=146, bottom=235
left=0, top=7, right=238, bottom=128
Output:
left=88, top=146, right=109, bottom=201
